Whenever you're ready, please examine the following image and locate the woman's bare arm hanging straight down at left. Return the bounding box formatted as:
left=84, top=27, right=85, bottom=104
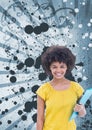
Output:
left=36, top=96, right=45, bottom=130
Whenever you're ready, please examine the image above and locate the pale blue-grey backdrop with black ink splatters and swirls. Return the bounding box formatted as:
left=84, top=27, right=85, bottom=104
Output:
left=0, top=0, right=92, bottom=130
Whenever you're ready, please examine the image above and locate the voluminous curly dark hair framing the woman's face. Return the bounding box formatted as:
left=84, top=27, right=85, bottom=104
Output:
left=41, top=45, right=76, bottom=76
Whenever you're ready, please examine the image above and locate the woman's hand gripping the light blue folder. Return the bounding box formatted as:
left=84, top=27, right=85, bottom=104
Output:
left=74, top=104, right=86, bottom=117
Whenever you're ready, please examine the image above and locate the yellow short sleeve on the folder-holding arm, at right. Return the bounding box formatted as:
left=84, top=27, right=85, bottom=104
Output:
left=73, top=82, right=84, bottom=98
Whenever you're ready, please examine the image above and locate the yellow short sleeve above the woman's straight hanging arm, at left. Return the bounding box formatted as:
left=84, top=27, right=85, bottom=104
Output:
left=36, top=84, right=47, bottom=100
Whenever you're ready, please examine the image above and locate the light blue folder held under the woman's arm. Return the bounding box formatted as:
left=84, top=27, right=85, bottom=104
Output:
left=69, top=88, right=92, bottom=121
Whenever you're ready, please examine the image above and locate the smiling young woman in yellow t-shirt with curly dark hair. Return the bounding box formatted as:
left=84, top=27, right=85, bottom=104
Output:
left=36, top=46, right=86, bottom=130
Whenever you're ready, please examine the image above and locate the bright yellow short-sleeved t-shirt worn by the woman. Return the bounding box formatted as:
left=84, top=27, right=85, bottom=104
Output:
left=36, top=81, right=84, bottom=130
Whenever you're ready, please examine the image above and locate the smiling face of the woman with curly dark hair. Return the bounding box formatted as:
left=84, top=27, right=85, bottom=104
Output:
left=50, top=62, right=67, bottom=79
